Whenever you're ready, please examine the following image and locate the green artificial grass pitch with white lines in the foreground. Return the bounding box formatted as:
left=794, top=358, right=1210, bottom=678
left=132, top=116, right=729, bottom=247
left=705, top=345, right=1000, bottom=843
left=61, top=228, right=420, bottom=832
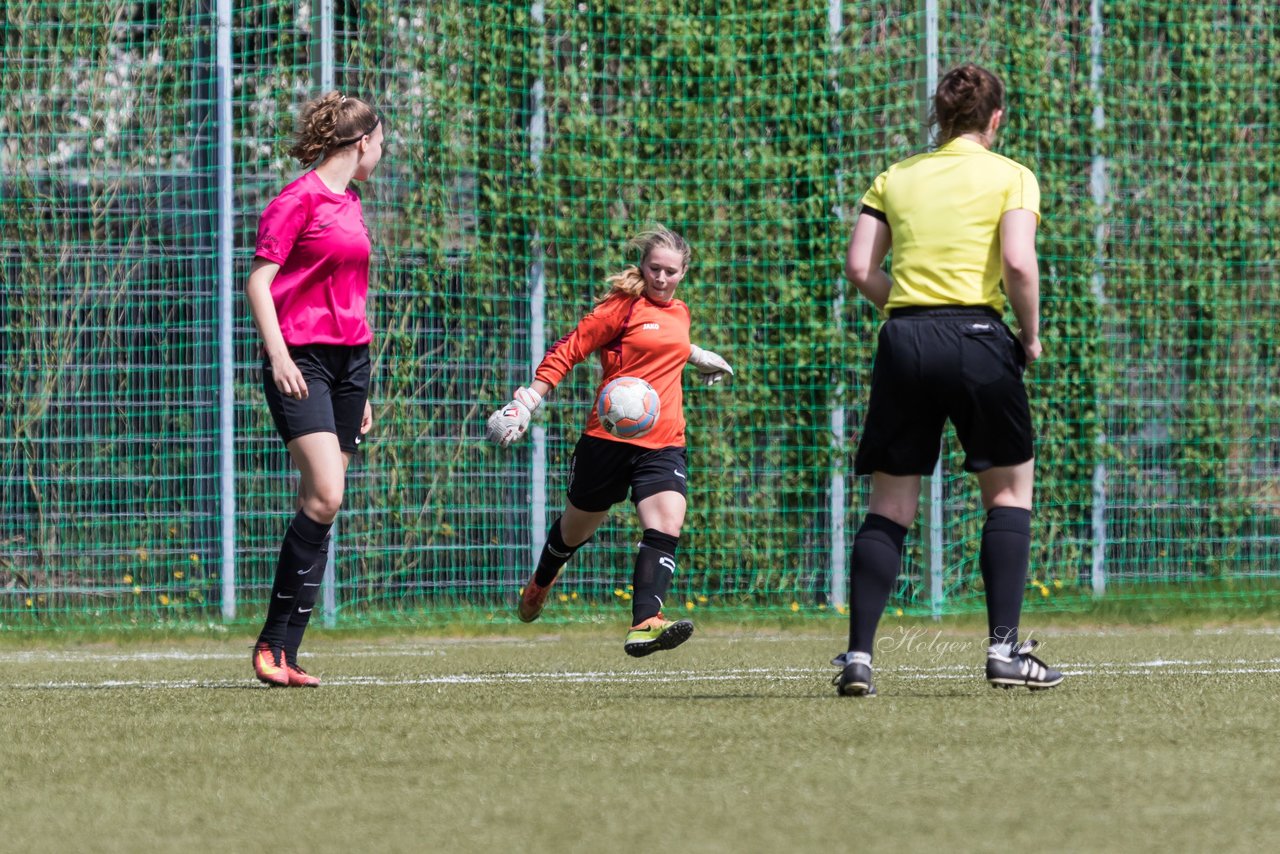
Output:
left=0, top=621, right=1280, bottom=851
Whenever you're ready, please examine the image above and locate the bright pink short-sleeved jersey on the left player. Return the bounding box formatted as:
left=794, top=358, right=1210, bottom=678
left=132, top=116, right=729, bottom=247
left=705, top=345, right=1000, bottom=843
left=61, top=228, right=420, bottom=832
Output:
left=253, top=172, right=374, bottom=346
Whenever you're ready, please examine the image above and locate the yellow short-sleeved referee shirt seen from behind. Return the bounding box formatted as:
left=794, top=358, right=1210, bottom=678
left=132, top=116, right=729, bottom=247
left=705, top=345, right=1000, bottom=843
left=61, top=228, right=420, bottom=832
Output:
left=863, top=138, right=1039, bottom=312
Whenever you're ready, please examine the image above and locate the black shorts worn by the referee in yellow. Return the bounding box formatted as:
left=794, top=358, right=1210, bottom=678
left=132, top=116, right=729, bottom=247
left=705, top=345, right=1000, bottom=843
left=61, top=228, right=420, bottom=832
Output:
left=854, top=306, right=1036, bottom=475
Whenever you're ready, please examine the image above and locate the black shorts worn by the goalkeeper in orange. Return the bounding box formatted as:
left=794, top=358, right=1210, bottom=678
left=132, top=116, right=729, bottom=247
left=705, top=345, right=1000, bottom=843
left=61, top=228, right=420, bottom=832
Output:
left=568, top=434, right=689, bottom=513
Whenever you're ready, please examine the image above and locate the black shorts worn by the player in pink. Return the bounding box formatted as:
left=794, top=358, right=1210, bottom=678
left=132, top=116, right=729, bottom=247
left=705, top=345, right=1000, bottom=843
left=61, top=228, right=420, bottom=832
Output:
left=262, top=344, right=370, bottom=453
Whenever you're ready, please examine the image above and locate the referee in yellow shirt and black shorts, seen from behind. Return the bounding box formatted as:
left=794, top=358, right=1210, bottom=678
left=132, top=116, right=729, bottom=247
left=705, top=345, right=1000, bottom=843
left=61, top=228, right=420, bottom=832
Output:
left=832, top=65, right=1062, bottom=697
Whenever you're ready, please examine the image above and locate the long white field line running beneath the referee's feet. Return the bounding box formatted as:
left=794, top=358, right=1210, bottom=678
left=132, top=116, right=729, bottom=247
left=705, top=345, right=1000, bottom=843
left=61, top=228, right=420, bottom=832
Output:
left=0, top=658, right=1280, bottom=690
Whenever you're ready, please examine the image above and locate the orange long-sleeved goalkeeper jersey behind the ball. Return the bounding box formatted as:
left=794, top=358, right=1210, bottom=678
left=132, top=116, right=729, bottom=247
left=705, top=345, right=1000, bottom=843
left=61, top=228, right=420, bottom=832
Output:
left=534, top=293, right=690, bottom=448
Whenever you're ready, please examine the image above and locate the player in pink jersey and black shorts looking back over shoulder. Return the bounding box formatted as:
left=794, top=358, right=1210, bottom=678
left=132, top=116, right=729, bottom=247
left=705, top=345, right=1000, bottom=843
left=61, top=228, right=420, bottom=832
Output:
left=246, top=92, right=383, bottom=688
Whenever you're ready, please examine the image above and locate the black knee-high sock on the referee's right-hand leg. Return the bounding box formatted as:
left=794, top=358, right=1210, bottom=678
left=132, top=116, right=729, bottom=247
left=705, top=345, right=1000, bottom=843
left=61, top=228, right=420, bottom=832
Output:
left=978, top=507, right=1032, bottom=644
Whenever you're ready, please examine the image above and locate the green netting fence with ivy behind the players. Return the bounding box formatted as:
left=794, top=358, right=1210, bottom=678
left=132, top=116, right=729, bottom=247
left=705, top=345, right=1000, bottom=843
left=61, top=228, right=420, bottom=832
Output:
left=0, top=0, right=1280, bottom=626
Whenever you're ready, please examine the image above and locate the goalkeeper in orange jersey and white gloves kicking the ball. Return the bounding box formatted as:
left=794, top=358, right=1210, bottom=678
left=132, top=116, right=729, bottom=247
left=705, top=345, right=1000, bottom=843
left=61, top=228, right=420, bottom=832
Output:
left=488, top=227, right=733, bottom=657
